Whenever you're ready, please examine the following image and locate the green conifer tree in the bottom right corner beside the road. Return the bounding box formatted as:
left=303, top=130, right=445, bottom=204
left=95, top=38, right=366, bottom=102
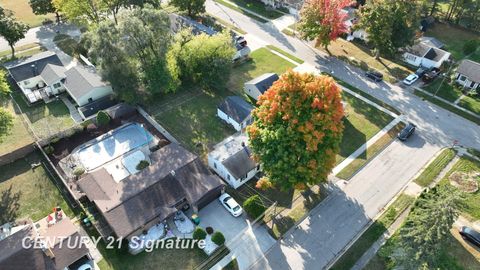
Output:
left=393, top=184, right=461, bottom=269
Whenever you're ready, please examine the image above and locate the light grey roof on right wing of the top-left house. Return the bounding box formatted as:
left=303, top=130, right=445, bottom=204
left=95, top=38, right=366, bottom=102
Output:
left=65, top=66, right=108, bottom=99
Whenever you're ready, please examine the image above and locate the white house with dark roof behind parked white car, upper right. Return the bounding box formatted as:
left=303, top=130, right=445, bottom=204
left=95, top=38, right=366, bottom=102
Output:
left=403, top=42, right=450, bottom=68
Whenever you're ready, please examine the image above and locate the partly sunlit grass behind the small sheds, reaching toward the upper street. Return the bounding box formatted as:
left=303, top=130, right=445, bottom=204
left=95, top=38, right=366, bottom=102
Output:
left=227, top=48, right=295, bottom=95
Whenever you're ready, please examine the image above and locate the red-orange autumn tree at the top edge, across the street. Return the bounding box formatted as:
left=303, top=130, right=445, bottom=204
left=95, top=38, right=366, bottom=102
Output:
left=298, top=0, right=352, bottom=49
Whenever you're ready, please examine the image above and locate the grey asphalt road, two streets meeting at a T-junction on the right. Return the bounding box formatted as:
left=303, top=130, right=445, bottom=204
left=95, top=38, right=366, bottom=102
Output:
left=206, top=0, right=480, bottom=270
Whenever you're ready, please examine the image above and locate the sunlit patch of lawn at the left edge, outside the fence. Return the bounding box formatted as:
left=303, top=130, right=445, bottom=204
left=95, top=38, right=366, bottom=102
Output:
left=0, top=100, right=33, bottom=155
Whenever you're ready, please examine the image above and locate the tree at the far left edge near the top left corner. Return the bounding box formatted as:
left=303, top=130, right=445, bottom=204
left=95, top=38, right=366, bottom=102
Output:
left=0, top=7, right=28, bottom=58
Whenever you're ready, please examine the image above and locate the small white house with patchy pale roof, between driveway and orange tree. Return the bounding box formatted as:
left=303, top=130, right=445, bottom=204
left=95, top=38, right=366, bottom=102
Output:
left=208, top=132, right=260, bottom=188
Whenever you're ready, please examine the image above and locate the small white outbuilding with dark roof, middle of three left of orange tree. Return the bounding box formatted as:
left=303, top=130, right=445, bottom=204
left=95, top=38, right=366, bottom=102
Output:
left=217, top=96, right=253, bottom=131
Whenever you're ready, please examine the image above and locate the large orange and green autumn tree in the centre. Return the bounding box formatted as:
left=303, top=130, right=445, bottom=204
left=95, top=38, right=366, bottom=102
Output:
left=247, top=71, right=343, bottom=190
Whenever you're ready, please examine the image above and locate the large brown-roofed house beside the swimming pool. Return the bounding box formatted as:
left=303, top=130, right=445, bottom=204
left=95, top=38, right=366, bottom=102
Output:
left=77, top=143, right=224, bottom=239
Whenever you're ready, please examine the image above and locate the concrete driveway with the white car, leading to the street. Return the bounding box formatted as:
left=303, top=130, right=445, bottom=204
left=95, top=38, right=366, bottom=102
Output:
left=199, top=200, right=276, bottom=269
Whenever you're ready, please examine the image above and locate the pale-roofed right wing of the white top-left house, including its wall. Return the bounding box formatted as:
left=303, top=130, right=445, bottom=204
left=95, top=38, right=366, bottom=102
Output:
left=64, top=65, right=113, bottom=107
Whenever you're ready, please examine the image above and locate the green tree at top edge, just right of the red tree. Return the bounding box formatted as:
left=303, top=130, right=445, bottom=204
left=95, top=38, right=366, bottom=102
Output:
left=355, top=0, right=419, bottom=57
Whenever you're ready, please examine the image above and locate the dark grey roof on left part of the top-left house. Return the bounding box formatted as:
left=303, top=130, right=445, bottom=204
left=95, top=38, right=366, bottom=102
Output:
left=6, top=51, right=63, bottom=82
